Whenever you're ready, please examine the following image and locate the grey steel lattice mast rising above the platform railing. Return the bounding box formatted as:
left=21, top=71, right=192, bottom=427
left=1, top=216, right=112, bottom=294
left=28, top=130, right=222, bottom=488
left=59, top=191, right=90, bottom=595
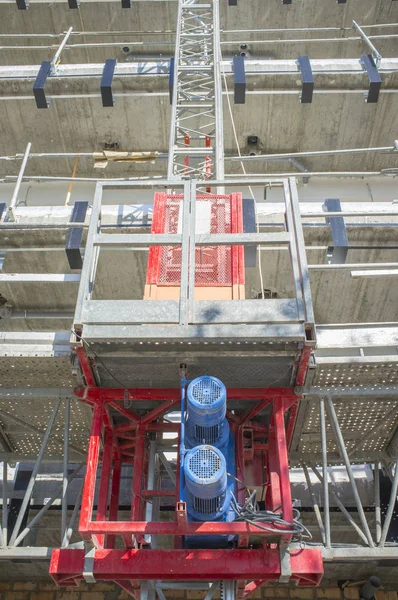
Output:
left=168, top=0, right=224, bottom=180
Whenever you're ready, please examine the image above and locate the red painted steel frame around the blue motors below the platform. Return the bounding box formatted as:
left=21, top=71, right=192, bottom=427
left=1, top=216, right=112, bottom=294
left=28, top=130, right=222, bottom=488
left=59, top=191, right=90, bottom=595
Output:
left=50, top=370, right=323, bottom=598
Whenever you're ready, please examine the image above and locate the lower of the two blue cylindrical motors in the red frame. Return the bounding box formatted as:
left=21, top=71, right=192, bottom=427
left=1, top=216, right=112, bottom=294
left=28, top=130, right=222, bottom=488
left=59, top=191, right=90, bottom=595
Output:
left=184, top=445, right=231, bottom=521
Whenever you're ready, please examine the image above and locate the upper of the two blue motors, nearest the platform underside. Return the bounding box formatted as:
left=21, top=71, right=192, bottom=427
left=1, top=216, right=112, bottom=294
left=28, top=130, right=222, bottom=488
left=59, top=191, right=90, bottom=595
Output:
left=186, top=375, right=229, bottom=451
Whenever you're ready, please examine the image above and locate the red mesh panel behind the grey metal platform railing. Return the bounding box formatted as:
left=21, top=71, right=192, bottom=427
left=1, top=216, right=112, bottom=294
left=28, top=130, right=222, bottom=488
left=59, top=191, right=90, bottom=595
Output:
left=147, top=194, right=243, bottom=286
